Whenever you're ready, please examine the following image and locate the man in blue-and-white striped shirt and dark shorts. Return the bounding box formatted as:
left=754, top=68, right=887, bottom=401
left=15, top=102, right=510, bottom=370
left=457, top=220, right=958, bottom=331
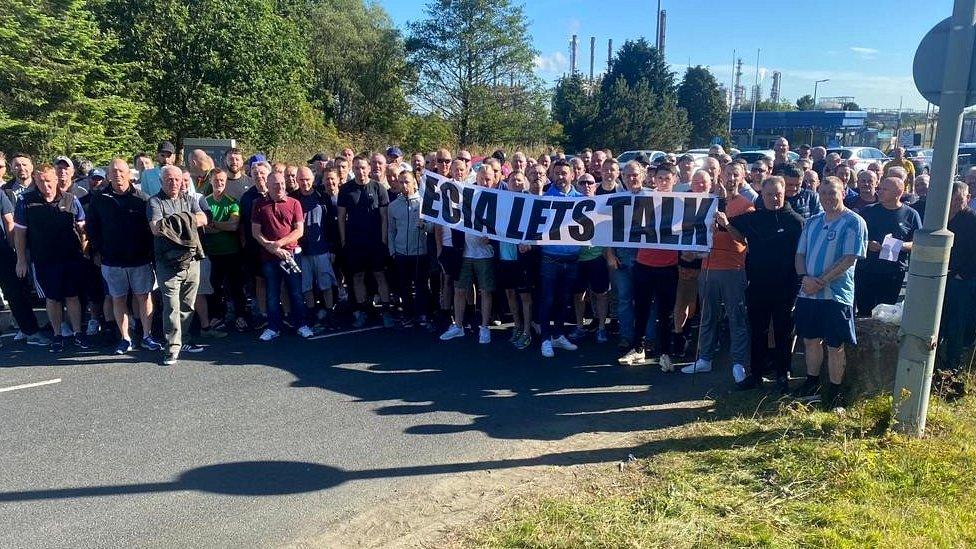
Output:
left=794, top=176, right=868, bottom=408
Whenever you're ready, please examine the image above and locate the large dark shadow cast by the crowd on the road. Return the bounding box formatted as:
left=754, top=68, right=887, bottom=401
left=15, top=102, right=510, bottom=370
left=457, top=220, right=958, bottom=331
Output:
left=3, top=322, right=776, bottom=440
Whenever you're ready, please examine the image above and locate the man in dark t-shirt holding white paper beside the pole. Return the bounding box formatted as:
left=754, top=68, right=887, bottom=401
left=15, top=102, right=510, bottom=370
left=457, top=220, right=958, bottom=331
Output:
left=854, top=177, right=922, bottom=317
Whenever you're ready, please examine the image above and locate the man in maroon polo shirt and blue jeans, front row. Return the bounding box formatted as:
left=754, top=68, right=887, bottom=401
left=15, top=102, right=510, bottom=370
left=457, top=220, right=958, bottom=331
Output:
left=251, top=173, right=312, bottom=341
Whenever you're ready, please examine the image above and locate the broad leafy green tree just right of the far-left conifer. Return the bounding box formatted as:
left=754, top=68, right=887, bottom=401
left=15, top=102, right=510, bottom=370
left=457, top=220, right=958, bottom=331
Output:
left=97, top=0, right=322, bottom=148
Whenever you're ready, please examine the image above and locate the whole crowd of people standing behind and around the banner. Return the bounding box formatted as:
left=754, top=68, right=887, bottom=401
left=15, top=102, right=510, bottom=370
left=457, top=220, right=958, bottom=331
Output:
left=0, top=138, right=976, bottom=402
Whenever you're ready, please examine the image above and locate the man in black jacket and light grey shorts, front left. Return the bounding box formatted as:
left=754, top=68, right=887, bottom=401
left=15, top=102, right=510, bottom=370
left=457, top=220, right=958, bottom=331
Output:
left=88, top=158, right=162, bottom=355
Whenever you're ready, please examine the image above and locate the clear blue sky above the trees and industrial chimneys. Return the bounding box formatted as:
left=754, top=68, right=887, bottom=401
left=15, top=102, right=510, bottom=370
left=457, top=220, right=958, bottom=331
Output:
left=377, top=0, right=952, bottom=110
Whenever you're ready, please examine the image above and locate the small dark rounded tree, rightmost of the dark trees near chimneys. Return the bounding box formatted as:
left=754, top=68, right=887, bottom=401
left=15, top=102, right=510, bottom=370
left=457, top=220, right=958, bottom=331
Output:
left=678, top=65, right=729, bottom=147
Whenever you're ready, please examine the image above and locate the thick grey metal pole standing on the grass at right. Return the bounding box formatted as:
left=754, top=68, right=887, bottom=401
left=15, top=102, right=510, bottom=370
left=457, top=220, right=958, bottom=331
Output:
left=893, top=0, right=976, bottom=437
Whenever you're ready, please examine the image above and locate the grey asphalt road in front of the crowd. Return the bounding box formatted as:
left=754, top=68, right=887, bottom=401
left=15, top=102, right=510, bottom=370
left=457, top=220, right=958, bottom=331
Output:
left=0, top=328, right=730, bottom=548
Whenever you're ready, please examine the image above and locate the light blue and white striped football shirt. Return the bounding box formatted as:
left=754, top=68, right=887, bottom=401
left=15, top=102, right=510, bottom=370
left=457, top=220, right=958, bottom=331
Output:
left=796, top=210, right=868, bottom=305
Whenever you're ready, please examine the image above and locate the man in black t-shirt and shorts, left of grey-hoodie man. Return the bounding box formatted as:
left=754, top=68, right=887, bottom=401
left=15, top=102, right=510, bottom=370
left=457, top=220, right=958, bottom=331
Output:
left=337, top=156, right=393, bottom=328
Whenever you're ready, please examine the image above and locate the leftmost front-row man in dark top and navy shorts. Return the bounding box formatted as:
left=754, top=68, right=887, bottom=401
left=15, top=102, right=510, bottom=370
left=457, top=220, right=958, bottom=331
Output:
left=14, top=165, right=88, bottom=352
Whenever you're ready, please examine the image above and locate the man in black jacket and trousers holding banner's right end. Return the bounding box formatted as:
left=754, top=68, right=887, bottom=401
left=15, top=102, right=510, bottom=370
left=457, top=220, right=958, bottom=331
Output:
left=716, top=176, right=803, bottom=393
